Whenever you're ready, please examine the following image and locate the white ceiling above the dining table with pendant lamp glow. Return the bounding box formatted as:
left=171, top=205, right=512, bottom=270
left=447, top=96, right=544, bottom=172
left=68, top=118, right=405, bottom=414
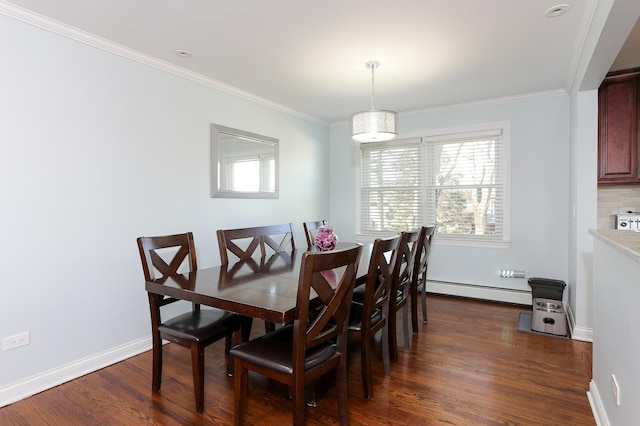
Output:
left=0, top=0, right=640, bottom=123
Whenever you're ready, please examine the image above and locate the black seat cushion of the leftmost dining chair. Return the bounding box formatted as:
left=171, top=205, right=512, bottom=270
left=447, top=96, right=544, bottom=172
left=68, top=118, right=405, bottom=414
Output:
left=158, top=309, right=243, bottom=342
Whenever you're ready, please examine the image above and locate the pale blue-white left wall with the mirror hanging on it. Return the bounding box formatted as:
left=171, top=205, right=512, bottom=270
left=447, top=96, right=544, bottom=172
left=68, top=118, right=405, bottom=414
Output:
left=0, top=11, right=329, bottom=406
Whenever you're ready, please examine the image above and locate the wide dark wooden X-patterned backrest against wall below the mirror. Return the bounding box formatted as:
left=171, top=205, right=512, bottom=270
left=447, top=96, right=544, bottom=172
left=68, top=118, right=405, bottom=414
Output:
left=217, top=223, right=296, bottom=265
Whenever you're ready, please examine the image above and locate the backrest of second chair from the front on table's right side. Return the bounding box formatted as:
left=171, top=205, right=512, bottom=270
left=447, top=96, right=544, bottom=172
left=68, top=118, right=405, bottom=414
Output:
left=362, top=235, right=400, bottom=329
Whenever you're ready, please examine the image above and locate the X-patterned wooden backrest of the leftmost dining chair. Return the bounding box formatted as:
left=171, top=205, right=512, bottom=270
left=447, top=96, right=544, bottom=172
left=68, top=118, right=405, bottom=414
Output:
left=137, top=232, right=198, bottom=281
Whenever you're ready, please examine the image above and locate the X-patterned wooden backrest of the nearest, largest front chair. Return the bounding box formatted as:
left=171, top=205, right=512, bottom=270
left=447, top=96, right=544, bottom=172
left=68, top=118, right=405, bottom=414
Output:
left=293, top=244, right=362, bottom=371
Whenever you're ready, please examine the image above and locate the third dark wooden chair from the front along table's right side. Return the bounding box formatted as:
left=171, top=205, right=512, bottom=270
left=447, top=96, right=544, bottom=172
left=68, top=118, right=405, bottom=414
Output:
left=389, top=229, right=420, bottom=361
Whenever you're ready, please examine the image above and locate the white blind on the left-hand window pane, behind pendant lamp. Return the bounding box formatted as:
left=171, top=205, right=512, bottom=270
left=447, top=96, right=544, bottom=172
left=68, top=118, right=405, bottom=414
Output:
left=360, top=138, right=424, bottom=233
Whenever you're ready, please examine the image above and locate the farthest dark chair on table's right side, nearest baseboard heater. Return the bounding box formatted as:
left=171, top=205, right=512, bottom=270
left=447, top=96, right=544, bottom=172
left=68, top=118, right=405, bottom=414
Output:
left=410, top=226, right=436, bottom=333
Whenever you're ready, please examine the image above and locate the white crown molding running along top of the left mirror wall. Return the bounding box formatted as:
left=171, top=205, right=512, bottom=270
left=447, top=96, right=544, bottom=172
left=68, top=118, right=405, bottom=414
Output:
left=0, top=0, right=329, bottom=126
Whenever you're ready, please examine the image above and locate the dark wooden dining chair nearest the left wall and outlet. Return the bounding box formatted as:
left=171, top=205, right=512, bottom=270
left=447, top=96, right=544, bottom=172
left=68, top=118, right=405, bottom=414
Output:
left=137, top=232, right=252, bottom=413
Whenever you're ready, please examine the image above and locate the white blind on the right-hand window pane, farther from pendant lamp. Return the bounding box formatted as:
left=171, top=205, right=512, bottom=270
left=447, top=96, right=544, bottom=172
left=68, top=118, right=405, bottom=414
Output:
left=425, top=129, right=505, bottom=241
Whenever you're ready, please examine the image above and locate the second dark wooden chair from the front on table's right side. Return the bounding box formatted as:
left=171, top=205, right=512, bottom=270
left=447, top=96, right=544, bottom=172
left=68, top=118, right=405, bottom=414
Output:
left=348, top=236, right=400, bottom=399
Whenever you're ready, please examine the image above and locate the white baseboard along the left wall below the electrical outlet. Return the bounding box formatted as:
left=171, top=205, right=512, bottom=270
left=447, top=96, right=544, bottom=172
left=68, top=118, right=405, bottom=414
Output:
left=0, top=337, right=151, bottom=407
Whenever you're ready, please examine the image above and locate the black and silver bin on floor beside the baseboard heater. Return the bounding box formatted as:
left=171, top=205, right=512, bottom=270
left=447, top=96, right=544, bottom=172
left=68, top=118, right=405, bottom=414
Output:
left=529, top=278, right=567, bottom=336
